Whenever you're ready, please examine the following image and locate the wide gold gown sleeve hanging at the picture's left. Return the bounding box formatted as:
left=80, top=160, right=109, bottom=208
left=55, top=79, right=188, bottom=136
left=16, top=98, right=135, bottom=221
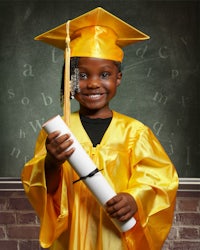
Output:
left=21, top=130, right=69, bottom=248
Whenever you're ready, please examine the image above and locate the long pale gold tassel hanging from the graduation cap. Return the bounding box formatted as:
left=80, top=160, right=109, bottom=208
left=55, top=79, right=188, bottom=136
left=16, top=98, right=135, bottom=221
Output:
left=64, top=20, right=71, bottom=126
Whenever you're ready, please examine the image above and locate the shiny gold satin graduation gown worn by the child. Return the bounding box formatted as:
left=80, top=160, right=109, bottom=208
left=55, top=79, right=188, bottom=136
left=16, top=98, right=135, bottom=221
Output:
left=22, top=111, right=178, bottom=250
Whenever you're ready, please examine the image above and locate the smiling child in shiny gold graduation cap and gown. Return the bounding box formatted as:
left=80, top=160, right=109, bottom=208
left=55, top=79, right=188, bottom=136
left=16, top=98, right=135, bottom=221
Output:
left=22, top=8, right=178, bottom=250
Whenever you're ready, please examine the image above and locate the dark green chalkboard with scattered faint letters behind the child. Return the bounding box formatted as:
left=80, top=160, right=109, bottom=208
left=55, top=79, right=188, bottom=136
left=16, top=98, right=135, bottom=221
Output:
left=0, top=0, right=200, bottom=178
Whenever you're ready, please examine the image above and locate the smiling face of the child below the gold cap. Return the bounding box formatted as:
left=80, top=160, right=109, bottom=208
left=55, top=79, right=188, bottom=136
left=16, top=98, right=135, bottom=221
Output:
left=75, top=57, right=122, bottom=114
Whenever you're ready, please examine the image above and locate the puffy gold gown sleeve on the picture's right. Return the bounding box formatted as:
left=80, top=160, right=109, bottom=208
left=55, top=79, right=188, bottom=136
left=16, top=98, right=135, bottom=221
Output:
left=125, top=128, right=178, bottom=250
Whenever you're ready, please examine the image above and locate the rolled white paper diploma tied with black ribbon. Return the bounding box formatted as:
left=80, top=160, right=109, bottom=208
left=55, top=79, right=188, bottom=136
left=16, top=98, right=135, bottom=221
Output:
left=42, top=115, right=136, bottom=232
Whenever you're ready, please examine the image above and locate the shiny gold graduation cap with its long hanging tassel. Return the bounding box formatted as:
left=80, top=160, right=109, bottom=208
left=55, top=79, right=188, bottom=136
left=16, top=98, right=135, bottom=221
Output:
left=35, top=7, right=149, bottom=124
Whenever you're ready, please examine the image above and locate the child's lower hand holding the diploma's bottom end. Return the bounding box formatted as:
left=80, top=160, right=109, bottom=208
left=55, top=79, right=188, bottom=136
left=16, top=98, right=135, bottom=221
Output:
left=106, top=193, right=137, bottom=222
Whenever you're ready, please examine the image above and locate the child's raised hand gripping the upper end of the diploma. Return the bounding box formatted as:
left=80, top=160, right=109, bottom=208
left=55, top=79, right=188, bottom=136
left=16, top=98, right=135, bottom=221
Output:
left=46, top=131, right=74, bottom=165
